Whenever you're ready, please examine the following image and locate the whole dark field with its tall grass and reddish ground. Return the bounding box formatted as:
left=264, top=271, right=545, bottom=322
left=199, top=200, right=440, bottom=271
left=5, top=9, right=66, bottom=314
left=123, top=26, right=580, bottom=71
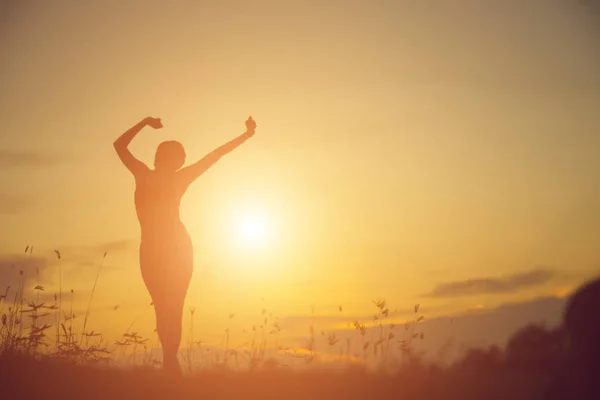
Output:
left=0, top=249, right=564, bottom=399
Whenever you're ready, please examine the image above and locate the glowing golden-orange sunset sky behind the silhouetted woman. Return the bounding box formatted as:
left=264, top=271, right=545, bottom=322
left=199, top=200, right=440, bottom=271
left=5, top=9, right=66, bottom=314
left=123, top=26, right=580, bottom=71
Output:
left=0, top=0, right=600, bottom=360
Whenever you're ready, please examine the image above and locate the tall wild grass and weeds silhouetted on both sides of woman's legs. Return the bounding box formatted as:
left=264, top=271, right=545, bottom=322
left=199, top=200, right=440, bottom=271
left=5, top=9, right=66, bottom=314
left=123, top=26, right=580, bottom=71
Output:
left=0, top=246, right=424, bottom=372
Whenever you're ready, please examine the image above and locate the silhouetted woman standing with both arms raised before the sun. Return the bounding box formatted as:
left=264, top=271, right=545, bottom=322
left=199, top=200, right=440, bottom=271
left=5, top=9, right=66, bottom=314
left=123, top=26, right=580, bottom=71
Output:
left=114, top=117, right=256, bottom=372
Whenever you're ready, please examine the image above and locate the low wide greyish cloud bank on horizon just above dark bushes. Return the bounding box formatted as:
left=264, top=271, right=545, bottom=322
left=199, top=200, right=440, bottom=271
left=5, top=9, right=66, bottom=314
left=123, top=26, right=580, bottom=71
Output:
left=280, top=297, right=566, bottom=361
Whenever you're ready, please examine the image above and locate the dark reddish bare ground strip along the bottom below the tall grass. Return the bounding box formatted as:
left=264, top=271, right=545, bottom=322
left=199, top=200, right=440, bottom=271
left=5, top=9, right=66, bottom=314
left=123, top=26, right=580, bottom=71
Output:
left=0, top=354, right=550, bottom=400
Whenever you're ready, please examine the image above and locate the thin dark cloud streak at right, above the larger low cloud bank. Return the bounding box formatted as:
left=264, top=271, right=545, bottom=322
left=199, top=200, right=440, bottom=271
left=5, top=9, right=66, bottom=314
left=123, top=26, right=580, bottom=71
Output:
left=425, top=268, right=555, bottom=297
